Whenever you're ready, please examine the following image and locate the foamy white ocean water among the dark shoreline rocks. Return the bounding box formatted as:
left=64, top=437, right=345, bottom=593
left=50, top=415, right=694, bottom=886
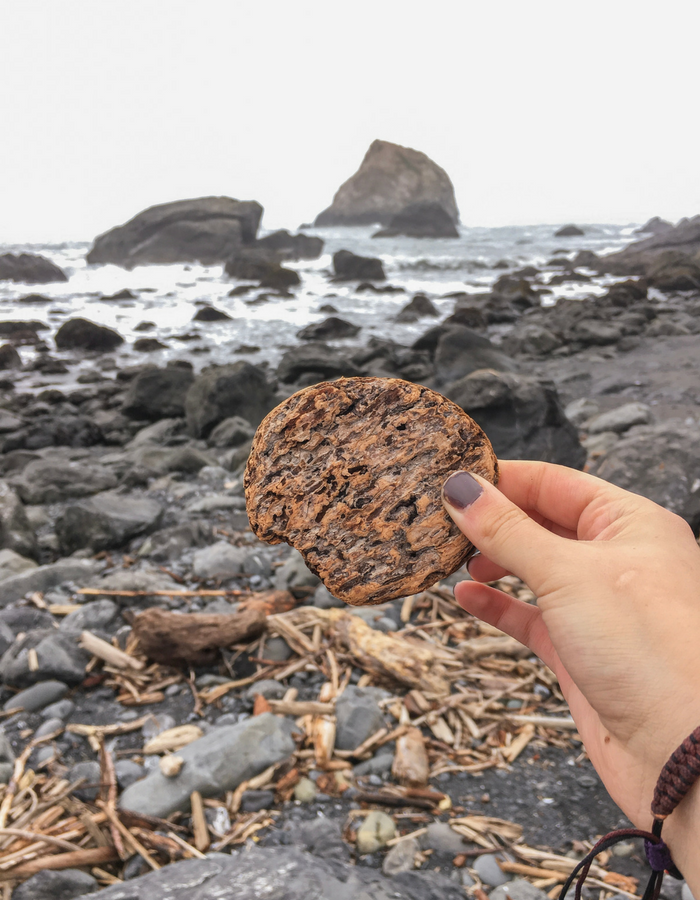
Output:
left=0, top=225, right=636, bottom=387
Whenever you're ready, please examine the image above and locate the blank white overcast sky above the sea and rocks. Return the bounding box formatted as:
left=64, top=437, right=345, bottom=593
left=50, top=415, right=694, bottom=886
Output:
left=0, top=0, right=700, bottom=242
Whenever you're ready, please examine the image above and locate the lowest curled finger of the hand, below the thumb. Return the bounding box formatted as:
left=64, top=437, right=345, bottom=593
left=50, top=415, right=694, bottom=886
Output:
left=454, top=581, right=563, bottom=677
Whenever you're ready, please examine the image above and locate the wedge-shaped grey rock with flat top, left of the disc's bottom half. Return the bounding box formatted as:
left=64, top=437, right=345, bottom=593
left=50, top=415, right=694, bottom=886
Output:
left=56, top=491, right=163, bottom=553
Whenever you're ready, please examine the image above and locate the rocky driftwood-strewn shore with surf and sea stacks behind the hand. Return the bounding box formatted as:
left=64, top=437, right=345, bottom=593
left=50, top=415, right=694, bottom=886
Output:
left=0, top=141, right=700, bottom=900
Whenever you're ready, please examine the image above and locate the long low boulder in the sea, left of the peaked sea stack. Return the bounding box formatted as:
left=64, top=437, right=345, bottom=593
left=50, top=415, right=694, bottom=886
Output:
left=87, top=197, right=263, bottom=269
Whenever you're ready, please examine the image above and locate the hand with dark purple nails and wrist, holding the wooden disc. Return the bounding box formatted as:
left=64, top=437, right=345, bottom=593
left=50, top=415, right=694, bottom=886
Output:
left=443, top=462, right=700, bottom=884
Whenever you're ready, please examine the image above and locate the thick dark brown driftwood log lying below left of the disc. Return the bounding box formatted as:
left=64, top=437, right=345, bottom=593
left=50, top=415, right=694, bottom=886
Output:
left=133, top=607, right=265, bottom=666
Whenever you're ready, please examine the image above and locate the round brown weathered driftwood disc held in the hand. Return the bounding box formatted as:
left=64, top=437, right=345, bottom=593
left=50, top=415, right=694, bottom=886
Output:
left=245, top=378, right=498, bottom=606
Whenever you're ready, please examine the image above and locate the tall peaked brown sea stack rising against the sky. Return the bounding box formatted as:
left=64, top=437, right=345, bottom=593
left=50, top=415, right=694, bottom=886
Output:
left=314, top=141, right=459, bottom=226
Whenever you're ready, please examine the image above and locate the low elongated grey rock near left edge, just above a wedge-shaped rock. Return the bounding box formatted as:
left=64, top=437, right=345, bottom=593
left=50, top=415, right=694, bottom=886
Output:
left=13, top=458, right=117, bottom=503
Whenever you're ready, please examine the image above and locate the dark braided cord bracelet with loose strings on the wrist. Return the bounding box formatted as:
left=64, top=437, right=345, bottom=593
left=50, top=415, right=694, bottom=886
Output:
left=559, top=726, right=700, bottom=900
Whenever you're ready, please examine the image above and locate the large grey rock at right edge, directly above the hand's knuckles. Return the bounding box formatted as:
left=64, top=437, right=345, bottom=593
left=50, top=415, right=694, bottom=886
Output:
left=588, top=422, right=700, bottom=528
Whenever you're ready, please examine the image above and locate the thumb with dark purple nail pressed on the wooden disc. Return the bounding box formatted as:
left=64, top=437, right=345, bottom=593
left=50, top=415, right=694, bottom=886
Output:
left=442, top=472, right=567, bottom=593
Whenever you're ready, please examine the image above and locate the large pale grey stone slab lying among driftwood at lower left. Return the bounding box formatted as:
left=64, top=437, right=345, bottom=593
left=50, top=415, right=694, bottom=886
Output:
left=119, top=713, right=296, bottom=818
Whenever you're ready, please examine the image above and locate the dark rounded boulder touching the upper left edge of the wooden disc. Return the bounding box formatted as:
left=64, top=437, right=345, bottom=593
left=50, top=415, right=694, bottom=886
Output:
left=185, top=361, right=275, bottom=438
